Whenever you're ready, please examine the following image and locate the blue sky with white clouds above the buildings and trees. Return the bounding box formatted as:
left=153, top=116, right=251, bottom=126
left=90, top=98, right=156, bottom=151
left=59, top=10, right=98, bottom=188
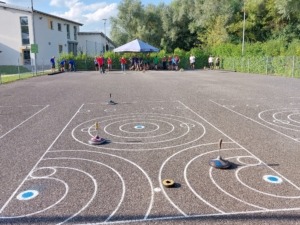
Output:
left=1, top=0, right=171, bottom=36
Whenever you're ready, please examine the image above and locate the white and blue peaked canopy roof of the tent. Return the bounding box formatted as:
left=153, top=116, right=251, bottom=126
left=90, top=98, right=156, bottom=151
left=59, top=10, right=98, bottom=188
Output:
left=114, top=39, right=159, bottom=52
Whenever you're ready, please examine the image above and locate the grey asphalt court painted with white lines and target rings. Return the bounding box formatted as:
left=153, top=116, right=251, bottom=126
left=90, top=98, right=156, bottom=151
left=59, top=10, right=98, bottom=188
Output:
left=0, top=70, right=300, bottom=225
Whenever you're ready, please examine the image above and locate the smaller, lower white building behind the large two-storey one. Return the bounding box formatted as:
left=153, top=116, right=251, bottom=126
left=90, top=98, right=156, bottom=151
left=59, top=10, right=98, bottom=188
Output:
left=78, top=32, right=115, bottom=56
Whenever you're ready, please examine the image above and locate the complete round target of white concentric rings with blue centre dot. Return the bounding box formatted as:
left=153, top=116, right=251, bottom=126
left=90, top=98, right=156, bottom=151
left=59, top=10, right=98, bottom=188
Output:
left=72, top=113, right=206, bottom=151
